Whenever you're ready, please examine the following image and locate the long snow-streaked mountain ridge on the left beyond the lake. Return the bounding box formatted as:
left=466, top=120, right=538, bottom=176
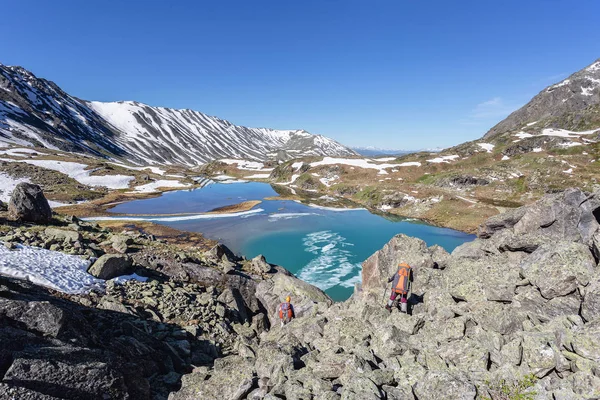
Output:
left=0, top=64, right=356, bottom=166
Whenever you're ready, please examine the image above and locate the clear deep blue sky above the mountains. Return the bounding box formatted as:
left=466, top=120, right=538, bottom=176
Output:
left=0, top=0, right=600, bottom=149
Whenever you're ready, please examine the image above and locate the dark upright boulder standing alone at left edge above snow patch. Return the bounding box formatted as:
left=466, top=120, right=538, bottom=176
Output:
left=8, top=182, right=52, bottom=223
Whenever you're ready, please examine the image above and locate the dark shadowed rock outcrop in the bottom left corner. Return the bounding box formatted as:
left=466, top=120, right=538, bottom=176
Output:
left=0, top=277, right=195, bottom=399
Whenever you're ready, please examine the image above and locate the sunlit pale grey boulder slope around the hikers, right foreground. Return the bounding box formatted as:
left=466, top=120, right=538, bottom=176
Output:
left=178, top=190, right=600, bottom=399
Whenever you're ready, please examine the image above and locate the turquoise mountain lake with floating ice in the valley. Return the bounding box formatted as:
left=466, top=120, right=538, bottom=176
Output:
left=110, top=182, right=474, bottom=300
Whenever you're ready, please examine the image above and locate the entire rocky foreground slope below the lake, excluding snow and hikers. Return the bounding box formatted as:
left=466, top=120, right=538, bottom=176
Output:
left=0, top=189, right=600, bottom=400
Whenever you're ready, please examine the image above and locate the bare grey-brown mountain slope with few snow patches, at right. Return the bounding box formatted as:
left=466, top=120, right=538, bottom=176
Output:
left=483, top=59, right=600, bottom=139
